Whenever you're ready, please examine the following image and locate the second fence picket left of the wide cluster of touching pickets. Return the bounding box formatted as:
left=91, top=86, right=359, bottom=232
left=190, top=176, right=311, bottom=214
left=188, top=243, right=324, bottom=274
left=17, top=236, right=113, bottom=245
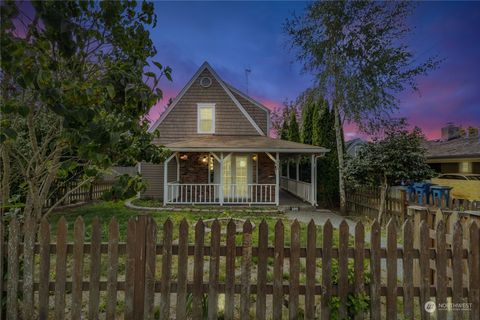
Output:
left=88, top=217, right=102, bottom=319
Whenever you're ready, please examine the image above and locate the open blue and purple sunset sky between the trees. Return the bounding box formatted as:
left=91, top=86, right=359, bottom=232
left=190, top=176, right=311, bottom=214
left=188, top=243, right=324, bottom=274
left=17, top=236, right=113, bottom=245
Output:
left=146, top=1, right=480, bottom=140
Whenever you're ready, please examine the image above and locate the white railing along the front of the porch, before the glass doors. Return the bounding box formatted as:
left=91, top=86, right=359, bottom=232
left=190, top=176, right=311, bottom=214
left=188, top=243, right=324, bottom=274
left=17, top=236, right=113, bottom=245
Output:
left=166, top=182, right=276, bottom=204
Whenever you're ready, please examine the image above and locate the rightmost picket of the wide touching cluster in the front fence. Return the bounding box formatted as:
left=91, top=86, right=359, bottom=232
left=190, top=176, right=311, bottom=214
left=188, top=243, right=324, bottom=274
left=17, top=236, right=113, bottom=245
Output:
left=144, top=218, right=158, bottom=319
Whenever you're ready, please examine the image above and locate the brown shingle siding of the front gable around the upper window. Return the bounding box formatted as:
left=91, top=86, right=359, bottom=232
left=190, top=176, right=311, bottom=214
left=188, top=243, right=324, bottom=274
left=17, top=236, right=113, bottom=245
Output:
left=157, top=69, right=259, bottom=144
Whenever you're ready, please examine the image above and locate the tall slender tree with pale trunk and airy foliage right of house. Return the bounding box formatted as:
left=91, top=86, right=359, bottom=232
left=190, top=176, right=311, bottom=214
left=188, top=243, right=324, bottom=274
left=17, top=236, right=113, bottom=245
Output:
left=285, top=1, right=438, bottom=212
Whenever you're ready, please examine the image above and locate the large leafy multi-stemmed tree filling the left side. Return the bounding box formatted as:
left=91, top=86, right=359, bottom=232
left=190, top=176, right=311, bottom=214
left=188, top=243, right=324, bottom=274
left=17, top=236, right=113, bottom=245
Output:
left=0, top=1, right=171, bottom=219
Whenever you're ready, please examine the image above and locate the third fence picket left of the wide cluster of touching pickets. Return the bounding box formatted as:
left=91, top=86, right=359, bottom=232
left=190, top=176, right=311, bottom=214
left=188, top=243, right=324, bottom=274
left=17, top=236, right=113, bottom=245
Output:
left=72, top=216, right=85, bottom=319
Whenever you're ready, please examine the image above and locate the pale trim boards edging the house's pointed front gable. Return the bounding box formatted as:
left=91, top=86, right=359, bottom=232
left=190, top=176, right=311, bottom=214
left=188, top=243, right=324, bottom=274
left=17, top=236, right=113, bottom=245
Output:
left=148, top=61, right=268, bottom=136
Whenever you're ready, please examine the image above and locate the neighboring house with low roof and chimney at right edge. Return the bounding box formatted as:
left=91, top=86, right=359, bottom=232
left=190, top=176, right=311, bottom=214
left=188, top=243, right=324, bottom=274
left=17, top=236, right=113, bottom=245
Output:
left=424, top=124, right=480, bottom=173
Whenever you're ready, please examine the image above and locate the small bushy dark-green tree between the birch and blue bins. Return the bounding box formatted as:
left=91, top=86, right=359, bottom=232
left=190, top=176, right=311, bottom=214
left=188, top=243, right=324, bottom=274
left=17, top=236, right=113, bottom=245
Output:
left=346, top=120, right=434, bottom=221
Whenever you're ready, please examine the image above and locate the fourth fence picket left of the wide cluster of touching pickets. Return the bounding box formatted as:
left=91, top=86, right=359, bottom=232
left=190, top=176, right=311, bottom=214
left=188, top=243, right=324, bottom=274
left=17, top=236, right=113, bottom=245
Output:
left=55, top=217, right=67, bottom=320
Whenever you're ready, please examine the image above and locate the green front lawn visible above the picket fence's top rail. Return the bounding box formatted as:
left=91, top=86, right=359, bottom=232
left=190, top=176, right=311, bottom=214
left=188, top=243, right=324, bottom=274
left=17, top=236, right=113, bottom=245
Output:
left=50, top=202, right=352, bottom=247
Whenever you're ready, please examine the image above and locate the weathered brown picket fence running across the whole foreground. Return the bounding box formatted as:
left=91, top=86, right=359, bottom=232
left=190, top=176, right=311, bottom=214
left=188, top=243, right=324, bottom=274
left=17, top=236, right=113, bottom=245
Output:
left=0, top=216, right=480, bottom=320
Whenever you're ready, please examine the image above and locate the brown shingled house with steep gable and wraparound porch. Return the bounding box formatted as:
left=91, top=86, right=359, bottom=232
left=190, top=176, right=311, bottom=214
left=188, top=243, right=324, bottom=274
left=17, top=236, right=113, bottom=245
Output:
left=139, top=62, right=328, bottom=206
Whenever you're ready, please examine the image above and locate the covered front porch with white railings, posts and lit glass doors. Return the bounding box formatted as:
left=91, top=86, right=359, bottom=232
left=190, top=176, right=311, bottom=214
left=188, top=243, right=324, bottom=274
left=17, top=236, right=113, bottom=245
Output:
left=163, top=136, right=325, bottom=206
